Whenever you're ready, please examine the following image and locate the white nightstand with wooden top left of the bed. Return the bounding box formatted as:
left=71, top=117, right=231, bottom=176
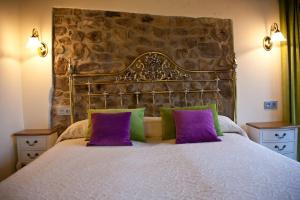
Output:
left=14, top=129, right=57, bottom=169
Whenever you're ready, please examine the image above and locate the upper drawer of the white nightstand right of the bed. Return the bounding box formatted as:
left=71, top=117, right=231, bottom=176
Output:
left=262, top=129, right=295, bottom=142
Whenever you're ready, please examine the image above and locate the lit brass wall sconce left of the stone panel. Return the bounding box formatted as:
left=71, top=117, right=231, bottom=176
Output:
left=26, top=28, right=48, bottom=57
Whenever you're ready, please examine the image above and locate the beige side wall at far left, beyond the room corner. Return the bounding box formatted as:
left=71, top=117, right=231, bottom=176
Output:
left=0, top=0, right=23, bottom=181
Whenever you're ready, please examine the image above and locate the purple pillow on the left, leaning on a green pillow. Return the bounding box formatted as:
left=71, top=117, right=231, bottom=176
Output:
left=87, top=112, right=132, bottom=146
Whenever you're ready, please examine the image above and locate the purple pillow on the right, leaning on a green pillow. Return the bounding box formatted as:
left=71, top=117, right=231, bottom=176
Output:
left=173, top=109, right=221, bottom=144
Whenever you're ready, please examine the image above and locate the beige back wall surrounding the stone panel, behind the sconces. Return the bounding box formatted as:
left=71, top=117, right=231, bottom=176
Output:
left=21, top=0, right=282, bottom=128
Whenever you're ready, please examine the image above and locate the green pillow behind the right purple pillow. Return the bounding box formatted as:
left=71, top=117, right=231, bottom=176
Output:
left=160, top=104, right=223, bottom=140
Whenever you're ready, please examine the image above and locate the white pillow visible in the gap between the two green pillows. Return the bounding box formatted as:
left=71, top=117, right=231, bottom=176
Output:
left=144, top=117, right=162, bottom=139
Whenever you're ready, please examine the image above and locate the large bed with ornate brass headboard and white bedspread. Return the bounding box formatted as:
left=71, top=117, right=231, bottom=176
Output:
left=0, top=52, right=300, bottom=200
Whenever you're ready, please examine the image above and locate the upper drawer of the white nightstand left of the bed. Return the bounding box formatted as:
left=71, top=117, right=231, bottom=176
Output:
left=17, top=136, right=47, bottom=150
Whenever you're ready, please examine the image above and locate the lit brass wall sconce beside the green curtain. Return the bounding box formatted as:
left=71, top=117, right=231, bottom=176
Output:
left=263, top=23, right=286, bottom=51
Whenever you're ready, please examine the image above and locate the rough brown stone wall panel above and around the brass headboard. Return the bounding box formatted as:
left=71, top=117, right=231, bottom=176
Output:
left=51, top=8, right=234, bottom=130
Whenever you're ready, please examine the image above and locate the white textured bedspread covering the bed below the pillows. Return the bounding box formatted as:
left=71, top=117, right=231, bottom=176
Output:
left=0, top=134, right=300, bottom=200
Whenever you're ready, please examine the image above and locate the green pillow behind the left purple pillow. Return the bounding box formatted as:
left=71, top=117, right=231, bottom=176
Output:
left=85, top=108, right=146, bottom=142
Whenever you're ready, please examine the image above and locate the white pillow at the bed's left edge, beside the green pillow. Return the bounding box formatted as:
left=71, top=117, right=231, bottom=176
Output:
left=56, top=119, right=88, bottom=143
